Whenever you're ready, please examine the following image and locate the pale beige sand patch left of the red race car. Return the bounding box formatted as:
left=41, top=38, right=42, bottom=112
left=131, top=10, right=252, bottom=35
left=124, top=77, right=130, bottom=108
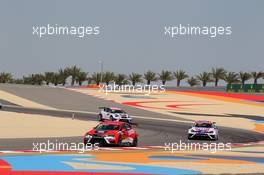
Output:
left=0, top=111, right=97, bottom=139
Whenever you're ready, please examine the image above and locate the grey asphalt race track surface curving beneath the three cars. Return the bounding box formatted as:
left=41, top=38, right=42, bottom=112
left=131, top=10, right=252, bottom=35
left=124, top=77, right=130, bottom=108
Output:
left=0, top=85, right=264, bottom=150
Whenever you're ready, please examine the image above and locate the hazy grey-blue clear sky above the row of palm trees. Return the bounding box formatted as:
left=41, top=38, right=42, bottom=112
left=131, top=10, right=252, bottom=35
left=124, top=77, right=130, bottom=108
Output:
left=0, top=0, right=264, bottom=77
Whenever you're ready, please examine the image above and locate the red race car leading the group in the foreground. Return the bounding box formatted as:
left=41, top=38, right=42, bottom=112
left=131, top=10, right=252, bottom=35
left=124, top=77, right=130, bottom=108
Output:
left=84, top=121, right=138, bottom=147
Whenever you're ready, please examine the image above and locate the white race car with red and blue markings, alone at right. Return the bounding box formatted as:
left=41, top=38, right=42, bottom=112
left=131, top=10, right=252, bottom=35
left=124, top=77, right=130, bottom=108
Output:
left=188, top=121, right=218, bottom=140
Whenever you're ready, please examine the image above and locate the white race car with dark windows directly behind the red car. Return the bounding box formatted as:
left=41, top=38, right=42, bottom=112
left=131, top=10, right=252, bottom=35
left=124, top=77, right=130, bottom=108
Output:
left=98, top=107, right=132, bottom=123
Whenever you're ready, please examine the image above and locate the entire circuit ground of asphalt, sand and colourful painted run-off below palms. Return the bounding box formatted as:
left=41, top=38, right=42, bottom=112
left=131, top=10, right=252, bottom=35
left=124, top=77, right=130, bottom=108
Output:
left=0, top=85, right=264, bottom=175
